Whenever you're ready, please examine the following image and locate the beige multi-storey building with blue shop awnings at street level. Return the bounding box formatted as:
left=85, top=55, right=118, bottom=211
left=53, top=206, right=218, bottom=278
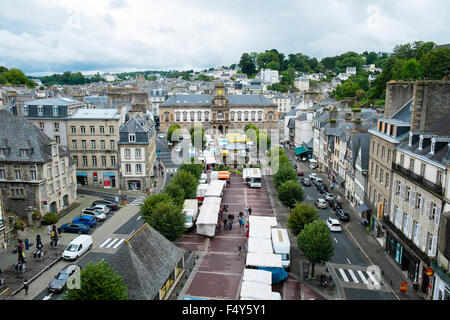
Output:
left=67, top=109, right=125, bottom=188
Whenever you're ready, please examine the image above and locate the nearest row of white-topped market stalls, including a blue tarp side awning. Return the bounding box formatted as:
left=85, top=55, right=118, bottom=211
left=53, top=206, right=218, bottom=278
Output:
left=241, top=216, right=287, bottom=300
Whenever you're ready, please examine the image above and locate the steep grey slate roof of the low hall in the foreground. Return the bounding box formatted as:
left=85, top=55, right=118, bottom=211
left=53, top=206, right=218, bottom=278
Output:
left=110, top=223, right=184, bottom=300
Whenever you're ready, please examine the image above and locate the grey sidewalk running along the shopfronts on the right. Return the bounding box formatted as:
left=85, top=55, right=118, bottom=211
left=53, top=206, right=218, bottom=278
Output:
left=285, top=149, right=423, bottom=300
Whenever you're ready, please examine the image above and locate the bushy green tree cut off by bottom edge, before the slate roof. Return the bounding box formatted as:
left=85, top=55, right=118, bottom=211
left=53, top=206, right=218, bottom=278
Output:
left=63, top=260, right=129, bottom=300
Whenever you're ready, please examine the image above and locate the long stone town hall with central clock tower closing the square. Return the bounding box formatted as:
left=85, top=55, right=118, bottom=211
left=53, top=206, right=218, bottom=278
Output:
left=159, top=84, right=278, bottom=135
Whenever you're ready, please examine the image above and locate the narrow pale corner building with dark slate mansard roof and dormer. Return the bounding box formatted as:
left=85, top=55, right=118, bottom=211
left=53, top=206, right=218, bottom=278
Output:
left=119, top=115, right=156, bottom=191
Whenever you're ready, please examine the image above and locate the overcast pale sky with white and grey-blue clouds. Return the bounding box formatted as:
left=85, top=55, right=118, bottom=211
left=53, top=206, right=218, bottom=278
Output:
left=0, top=0, right=450, bottom=75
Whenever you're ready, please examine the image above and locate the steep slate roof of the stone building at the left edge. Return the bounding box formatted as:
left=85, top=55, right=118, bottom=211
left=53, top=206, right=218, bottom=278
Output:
left=0, top=110, right=68, bottom=163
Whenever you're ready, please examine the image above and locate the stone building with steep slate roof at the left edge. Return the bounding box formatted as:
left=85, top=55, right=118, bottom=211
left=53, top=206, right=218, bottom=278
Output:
left=0, top=110, right=77, bottom=224
